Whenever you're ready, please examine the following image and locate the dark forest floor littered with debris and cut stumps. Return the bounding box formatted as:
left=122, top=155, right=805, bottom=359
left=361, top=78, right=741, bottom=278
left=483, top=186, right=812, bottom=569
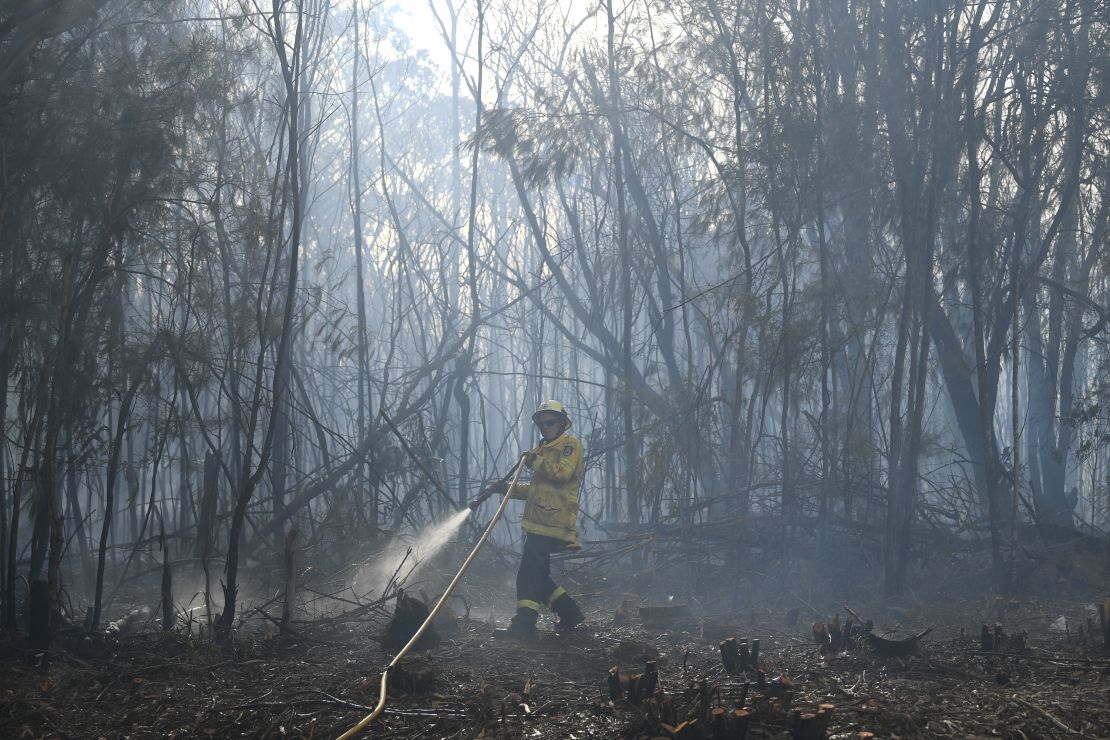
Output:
left=0, top=534, right=1110, bottom=739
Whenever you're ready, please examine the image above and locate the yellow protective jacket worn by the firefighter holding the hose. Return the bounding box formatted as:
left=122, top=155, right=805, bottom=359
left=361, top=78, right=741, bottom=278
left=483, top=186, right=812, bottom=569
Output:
left=512, top=432, right=582, bottom=549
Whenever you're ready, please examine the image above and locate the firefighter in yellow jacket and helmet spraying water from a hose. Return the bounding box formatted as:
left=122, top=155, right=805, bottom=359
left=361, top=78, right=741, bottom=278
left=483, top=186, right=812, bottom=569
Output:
left=471, top=401, right=585, bottom=638
